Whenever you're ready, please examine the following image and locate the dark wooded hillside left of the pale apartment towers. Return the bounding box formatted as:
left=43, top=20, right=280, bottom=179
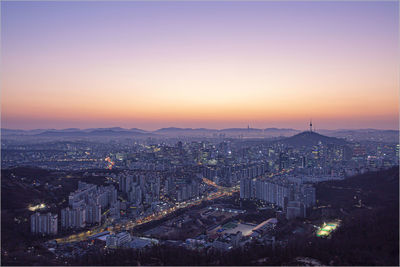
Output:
left=1, top=167, right=112, bottom=266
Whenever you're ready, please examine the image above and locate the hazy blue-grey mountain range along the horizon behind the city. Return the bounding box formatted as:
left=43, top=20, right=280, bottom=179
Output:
left=1, top=127, right=399, bottom=142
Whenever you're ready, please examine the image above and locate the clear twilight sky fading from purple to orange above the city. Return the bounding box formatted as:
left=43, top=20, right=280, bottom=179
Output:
left=1, top=1, right=400, bottom=130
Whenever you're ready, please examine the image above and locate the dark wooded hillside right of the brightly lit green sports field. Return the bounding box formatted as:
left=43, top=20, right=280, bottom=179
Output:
left=310, top=167, right=399, bottom=266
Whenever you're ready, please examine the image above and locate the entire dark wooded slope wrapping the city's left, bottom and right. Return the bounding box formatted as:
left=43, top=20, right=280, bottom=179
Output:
left=2, top=168, right=399, bottom=266
